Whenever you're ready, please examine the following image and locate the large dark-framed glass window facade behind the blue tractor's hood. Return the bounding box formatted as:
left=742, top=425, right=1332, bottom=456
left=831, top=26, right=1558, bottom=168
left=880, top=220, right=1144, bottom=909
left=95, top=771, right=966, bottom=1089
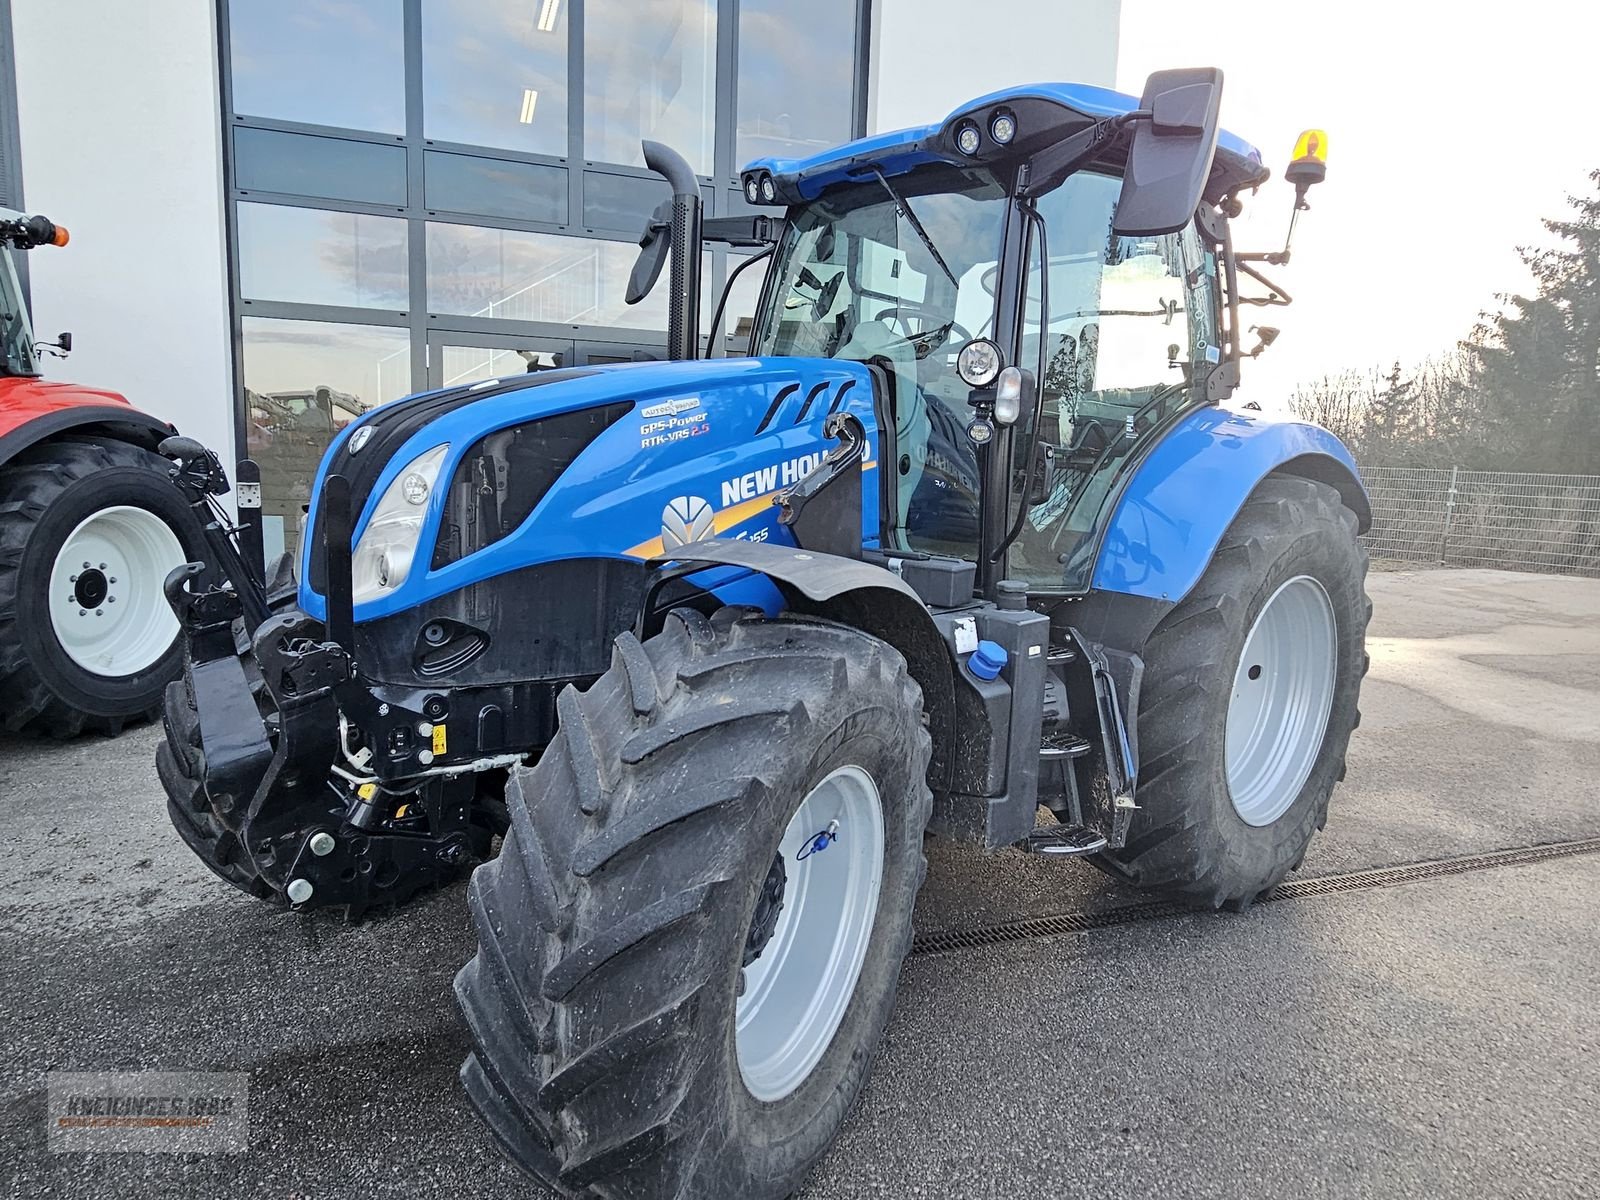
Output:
left=218, top=0, right=870, bottom=518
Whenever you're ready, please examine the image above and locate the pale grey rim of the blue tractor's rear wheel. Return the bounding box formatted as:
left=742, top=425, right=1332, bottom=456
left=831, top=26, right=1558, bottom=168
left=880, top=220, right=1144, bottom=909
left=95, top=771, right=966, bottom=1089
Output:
left=1226, top=574, right=1339, bottom=826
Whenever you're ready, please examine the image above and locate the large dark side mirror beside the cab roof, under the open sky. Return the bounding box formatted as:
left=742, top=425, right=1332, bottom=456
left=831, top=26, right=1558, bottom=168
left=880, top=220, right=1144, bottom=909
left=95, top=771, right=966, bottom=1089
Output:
left=1112, top=67, right=1222, bottom=237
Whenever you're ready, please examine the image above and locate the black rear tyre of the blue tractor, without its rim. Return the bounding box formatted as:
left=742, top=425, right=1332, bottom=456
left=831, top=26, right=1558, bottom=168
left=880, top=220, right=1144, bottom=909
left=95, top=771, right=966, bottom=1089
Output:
left=1093, top=475, right=1373, bottom=909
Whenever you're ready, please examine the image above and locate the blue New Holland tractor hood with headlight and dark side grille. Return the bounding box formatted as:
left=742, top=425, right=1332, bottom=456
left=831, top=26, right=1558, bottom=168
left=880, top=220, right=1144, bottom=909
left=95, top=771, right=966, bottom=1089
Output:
left=301, top=358, right=878, bottom=622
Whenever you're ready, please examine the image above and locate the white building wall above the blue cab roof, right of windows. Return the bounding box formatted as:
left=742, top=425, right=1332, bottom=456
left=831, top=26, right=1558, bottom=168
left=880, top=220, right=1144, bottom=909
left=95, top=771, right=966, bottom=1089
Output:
left=867, top=0, right=1122, bottom=133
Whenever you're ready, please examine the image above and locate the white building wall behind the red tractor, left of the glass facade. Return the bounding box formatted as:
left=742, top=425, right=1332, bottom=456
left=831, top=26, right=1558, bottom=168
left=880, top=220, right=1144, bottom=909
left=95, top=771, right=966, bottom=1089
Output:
left=11, top=0, right=234, bottom=472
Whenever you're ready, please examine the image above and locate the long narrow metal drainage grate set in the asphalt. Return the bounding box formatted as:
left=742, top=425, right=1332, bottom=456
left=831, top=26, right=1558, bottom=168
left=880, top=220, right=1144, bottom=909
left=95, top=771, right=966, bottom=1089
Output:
left=910, top=837, right=1600, bottom=955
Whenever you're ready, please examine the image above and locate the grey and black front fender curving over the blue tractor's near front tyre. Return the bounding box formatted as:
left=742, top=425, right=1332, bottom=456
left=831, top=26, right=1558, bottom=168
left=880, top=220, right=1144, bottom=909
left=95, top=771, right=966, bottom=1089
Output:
left=653, top=538, right=955, bottom=790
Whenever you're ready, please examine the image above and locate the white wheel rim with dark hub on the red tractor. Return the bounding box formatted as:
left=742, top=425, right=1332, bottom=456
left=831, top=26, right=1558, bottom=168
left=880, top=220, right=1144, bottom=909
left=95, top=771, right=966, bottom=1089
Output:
left=50, top=506, right=187, bottom=678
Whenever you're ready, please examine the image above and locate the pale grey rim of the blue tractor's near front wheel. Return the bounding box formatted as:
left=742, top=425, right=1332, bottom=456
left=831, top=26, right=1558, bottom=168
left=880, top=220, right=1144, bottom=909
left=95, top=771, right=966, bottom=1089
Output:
left=736, top=766, right=883, bottom=1102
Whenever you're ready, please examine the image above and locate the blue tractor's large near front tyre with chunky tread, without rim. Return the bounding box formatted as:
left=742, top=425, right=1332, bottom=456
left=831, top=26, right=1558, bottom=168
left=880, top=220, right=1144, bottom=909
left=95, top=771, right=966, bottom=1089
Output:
left=456, top=610, right=933, bottom=1200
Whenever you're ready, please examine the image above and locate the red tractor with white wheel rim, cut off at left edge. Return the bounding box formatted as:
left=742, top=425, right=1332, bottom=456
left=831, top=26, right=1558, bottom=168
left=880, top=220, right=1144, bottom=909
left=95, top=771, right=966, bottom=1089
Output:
left=0, top=208, right=203, bottom=738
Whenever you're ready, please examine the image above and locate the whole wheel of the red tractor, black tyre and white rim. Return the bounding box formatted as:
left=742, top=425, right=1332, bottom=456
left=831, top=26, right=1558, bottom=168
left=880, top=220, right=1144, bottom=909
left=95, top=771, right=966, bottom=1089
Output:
left=0, top=442, right=205, bottom=738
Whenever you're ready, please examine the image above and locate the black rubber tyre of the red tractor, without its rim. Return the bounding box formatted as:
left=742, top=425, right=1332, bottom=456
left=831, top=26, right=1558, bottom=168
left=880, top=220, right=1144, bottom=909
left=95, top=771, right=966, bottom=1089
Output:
left=0, top=442, right=205, bottom=738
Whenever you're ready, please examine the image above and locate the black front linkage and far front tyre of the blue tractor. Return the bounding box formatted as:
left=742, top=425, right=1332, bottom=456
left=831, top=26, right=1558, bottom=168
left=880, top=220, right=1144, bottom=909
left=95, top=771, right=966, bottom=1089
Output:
left=157, top=438, right=502, bottom=920
